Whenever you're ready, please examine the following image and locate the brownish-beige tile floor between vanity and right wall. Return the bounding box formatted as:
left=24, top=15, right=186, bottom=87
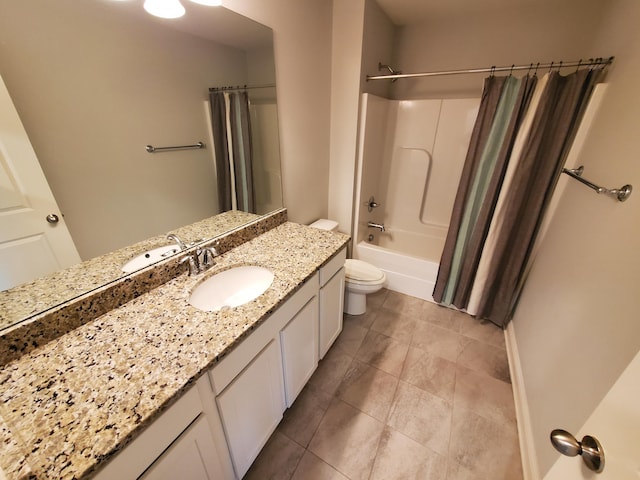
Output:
left=245, top=290, right=522, bottom=480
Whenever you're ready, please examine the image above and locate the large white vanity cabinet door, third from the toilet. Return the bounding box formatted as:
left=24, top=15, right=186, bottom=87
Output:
left=217, top=337, right=285, bottom=478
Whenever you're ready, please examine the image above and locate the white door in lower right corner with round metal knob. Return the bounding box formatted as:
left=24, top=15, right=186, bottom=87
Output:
left=544, top=352, right=640, bottom=480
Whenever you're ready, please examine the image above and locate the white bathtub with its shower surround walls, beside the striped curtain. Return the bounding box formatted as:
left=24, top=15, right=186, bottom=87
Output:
left=352, top=94, right=480, bottom=301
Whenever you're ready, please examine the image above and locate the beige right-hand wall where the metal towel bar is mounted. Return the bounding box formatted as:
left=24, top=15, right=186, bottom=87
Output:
left=514, top=0, right=640, bottom=475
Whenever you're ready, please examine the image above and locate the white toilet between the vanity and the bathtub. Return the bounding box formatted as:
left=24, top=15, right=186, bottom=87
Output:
left=310, top=219, right=387, bottom=315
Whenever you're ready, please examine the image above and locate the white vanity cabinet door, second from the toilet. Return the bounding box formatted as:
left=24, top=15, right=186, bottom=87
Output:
left=280, top=296, right=318, bottom=407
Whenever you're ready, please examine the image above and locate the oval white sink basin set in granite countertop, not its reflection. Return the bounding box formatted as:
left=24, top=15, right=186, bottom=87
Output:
left=189, top=265, right=273, bottom=312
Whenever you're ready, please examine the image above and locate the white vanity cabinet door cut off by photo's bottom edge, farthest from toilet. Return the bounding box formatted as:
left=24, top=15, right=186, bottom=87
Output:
left=140, top=415, right=225, bottom=480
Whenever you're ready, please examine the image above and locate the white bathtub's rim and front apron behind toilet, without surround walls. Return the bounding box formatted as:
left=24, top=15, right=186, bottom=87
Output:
left=354, top=242, right=438, bottom=302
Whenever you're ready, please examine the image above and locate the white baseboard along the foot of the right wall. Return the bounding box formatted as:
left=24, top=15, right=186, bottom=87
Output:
left=504, top=322, right=540, bottom=480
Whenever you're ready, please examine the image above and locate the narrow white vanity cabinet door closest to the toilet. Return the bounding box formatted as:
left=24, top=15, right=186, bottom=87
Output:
left=319, top=267, right=344, bottom=358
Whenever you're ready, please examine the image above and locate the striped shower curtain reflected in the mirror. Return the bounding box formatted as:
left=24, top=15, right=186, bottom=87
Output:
left=209, top=91, right=256, bottom=213
